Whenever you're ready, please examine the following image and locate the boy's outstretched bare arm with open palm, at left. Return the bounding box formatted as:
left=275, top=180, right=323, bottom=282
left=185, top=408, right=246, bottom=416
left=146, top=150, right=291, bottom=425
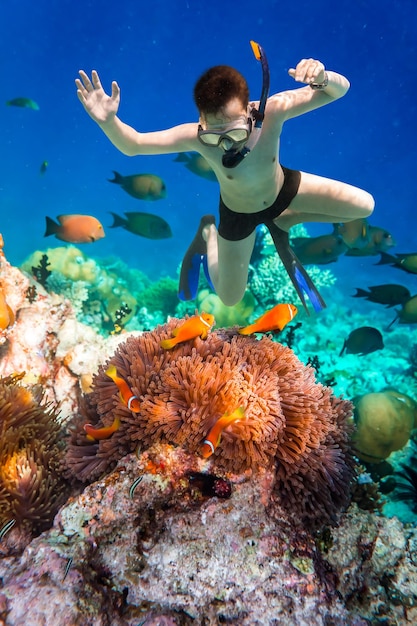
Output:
left=75, top=70, right=197, bottom=156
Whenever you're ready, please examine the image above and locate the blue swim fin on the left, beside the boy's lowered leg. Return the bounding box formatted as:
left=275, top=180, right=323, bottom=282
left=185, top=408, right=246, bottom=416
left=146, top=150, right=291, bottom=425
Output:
left=178, top=215, right=216, bottom=300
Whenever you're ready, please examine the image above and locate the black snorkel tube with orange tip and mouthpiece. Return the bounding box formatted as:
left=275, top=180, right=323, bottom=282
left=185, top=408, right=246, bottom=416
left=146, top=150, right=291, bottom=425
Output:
left=222, top=40, right=270, bottom=168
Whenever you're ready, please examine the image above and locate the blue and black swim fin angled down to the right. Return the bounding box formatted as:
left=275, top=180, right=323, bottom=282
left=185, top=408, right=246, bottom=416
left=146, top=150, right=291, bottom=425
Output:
left=265, top=221, right=326, bottom=315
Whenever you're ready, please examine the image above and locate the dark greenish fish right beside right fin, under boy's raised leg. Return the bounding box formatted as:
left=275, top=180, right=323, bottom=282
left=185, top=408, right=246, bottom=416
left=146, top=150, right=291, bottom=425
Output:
left=291, top=233, right=347, bottom=265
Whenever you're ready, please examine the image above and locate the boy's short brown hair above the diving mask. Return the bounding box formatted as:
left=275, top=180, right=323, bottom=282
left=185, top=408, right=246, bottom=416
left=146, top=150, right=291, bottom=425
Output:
left=194, top=65, right=249, bottom=113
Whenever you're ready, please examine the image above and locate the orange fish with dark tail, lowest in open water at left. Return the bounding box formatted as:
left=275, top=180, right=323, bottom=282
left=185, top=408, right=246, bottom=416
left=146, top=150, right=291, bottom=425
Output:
left=44, top=214, right=105, bottom=243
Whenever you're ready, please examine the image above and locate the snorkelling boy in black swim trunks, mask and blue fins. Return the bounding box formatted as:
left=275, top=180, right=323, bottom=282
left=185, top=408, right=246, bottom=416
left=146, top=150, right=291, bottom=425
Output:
left=75, top=41, right=374, bottom=311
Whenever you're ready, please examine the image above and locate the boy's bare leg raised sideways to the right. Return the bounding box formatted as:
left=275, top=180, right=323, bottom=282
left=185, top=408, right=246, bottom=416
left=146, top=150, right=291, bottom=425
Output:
left=275, top=172, right=375, bottom=230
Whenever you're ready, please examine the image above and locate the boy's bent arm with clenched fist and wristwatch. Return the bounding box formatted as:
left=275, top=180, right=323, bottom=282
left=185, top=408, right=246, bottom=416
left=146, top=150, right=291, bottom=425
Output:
left=268, top=59, right=350, bottom=122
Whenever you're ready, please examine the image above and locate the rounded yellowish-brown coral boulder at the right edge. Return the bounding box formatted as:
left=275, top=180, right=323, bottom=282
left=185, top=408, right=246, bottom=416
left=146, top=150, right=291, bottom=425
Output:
left=353, top=389, right=417, bottom=463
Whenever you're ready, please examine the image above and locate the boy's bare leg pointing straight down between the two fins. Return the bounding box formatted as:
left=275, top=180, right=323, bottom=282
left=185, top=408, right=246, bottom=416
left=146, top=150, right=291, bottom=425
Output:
left=203, top=224, right=255, bottom=306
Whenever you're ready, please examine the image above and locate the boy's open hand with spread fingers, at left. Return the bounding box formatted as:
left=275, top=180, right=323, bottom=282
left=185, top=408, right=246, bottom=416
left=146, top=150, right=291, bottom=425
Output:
left=75, top=70, right=120, bottom=124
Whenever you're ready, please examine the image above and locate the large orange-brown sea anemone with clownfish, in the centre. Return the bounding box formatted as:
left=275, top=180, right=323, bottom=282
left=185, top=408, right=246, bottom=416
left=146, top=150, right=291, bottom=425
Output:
left=67, top=319, right=353, bottom=521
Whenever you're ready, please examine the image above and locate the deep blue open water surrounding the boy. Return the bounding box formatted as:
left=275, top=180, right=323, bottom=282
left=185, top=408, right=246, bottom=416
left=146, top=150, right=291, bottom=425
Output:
left=0, top=0, right=417, bottom=292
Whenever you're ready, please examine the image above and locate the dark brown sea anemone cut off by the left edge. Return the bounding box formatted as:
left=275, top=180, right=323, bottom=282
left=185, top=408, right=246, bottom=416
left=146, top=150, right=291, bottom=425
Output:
left=0, top=375, right=66, bottom=534
